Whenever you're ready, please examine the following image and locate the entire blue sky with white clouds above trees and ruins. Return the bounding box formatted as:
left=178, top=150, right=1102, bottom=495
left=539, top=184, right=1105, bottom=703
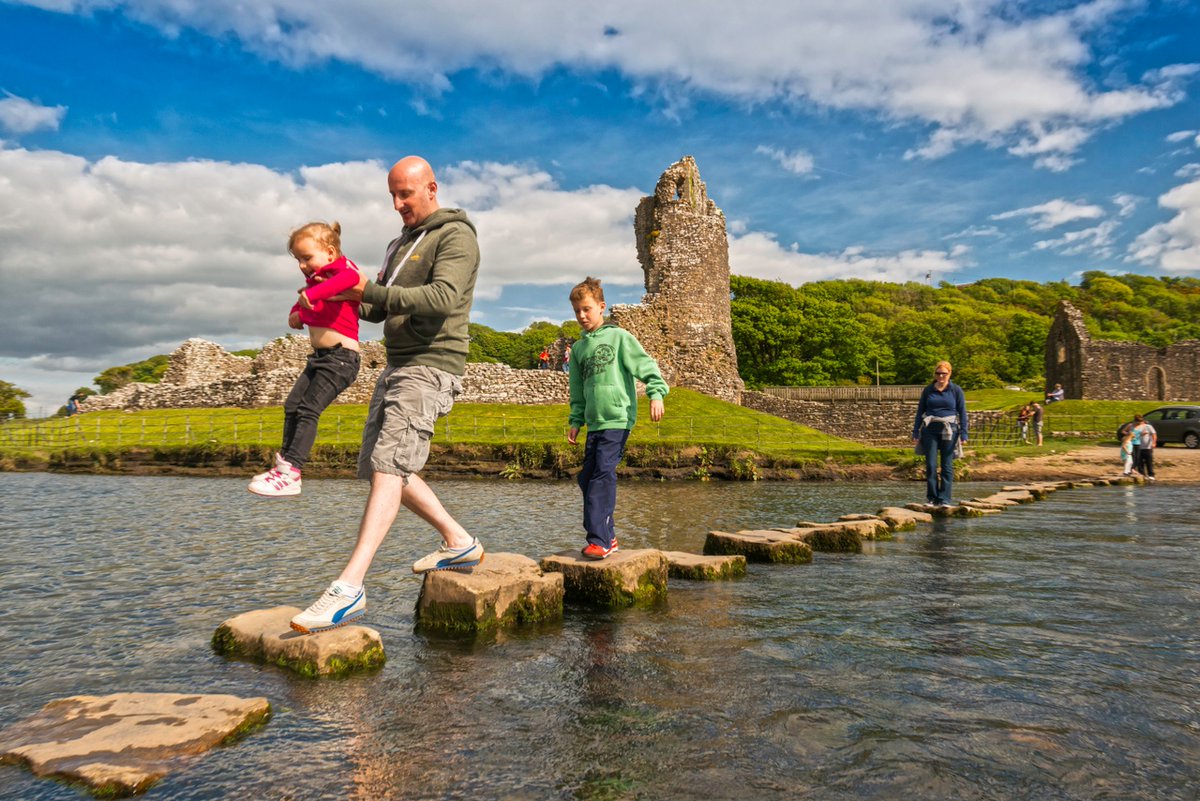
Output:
left=0, top=0, right=1200, bottom=414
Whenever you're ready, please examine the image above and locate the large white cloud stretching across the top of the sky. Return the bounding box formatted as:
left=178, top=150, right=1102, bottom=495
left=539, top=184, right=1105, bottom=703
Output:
left=21, top=0, right=1195, bottom=164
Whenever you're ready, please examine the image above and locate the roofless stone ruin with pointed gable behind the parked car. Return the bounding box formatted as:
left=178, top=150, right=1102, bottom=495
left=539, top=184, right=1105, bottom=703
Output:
left=1045, top=301, right=1200, bottom=401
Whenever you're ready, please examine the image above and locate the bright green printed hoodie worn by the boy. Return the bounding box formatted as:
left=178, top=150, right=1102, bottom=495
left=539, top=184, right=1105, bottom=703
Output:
left=569, top=323, right=668, bottom=433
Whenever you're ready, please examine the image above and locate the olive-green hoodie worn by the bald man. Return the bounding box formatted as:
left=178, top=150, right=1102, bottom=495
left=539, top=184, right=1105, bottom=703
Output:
left=359, top=209, right=479, bottom=375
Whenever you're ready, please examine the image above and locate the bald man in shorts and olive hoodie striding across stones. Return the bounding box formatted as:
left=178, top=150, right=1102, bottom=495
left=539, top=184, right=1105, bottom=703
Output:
left=292, top=156, right=484, bottom=634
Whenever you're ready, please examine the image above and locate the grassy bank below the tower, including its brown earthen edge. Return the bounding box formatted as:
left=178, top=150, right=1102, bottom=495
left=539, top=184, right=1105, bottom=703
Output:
left=0, top=389, right=907, bottom=478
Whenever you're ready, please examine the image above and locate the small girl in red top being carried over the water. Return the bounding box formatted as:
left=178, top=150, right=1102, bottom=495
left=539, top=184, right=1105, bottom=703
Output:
left=247, top=222, right=361, bottom=498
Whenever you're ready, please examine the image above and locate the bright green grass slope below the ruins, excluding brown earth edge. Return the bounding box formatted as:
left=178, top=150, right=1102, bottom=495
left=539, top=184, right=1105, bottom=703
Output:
left=0, top=387, right=896, bottom=462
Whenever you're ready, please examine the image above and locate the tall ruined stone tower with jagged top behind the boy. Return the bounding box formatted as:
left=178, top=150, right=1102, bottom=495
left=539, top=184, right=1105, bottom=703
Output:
left=612, top=156, right=744, bottom=403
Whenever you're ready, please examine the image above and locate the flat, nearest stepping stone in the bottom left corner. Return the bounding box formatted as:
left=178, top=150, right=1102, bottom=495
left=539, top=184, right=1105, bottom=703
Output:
left=0, top=693, right=271, bottom=797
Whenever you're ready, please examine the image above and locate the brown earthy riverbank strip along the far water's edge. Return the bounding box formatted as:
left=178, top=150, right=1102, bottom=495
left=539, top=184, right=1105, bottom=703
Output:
left=0, top=444, right=1200, bottom=482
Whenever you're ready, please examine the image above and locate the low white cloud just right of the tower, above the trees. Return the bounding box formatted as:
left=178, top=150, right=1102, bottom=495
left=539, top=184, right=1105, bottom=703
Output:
left=730, top=231, right=967, bottom=285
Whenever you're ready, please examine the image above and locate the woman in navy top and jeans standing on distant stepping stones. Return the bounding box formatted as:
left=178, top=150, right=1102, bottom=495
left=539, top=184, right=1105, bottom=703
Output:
left=912, top=361, right=967, bottom=506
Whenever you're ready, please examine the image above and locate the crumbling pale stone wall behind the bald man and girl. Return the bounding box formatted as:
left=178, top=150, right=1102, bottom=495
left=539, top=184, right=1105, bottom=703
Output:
left=80, top=335, right=568, bottom=411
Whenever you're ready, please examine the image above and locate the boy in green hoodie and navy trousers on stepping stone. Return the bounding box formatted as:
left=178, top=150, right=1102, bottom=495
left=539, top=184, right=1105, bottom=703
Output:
left=566, top=276, right=667, bottom=559
